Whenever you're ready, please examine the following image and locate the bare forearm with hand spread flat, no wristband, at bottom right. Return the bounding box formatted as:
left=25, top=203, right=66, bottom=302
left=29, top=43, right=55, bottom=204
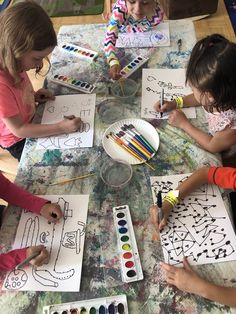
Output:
left=160, top=258, right=236, bottom=307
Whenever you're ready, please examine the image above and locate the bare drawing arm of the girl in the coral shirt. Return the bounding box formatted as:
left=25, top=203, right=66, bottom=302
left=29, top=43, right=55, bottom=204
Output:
left=2, top=115, right=82, bottom=138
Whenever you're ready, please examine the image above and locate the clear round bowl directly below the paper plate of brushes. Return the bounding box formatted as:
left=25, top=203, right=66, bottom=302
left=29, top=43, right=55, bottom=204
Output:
left=100, top=158, right=133, bottom=189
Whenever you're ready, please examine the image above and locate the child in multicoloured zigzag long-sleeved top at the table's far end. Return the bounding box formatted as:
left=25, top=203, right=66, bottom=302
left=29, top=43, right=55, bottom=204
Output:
left=104, top=0, right=163, bottom=80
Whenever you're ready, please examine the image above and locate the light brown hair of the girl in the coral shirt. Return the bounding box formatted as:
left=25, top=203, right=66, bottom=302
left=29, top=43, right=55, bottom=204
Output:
left=0, top=1, right=57, bottom=84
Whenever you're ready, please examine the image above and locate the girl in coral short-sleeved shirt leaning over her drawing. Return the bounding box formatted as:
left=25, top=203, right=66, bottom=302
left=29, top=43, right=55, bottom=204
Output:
left=0, top=1, right=81, bottom=160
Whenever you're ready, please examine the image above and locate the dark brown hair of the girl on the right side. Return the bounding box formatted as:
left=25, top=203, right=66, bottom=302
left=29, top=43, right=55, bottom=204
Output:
left=186, top=34, right=236, bottom=112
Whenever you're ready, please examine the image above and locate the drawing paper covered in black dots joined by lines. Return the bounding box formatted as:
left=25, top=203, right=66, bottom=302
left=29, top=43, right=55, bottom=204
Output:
left=150, top=174, right=236, bottom=266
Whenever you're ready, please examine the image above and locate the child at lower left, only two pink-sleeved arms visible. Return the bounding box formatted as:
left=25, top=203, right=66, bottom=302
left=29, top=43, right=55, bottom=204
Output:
left=0, top=173, right=62, bottom=271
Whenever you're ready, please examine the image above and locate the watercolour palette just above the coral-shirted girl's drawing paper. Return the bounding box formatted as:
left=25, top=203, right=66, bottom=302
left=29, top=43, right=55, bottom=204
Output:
left=50, top=74, right=96, bottom=94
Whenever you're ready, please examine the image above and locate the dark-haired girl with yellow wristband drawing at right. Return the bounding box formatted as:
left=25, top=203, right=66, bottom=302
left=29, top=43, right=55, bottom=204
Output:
left=155, top=34, right=236, bottom=165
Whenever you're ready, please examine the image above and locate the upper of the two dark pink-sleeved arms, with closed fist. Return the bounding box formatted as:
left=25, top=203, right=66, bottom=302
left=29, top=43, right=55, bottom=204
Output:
left=0, top=173, right=62, bottom=223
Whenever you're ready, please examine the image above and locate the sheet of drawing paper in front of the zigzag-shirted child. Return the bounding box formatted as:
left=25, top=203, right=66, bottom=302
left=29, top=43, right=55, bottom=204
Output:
left=116, top=22, right=170, bottom=48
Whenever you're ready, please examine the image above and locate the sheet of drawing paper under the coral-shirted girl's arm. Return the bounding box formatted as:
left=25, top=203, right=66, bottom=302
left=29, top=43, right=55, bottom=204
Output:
left=36, top=94, right=96, bottom=149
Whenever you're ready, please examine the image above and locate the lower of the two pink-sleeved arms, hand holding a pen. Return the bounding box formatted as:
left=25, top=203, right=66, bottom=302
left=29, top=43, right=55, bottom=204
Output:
left=0, top=245, right=49, bottom=271
